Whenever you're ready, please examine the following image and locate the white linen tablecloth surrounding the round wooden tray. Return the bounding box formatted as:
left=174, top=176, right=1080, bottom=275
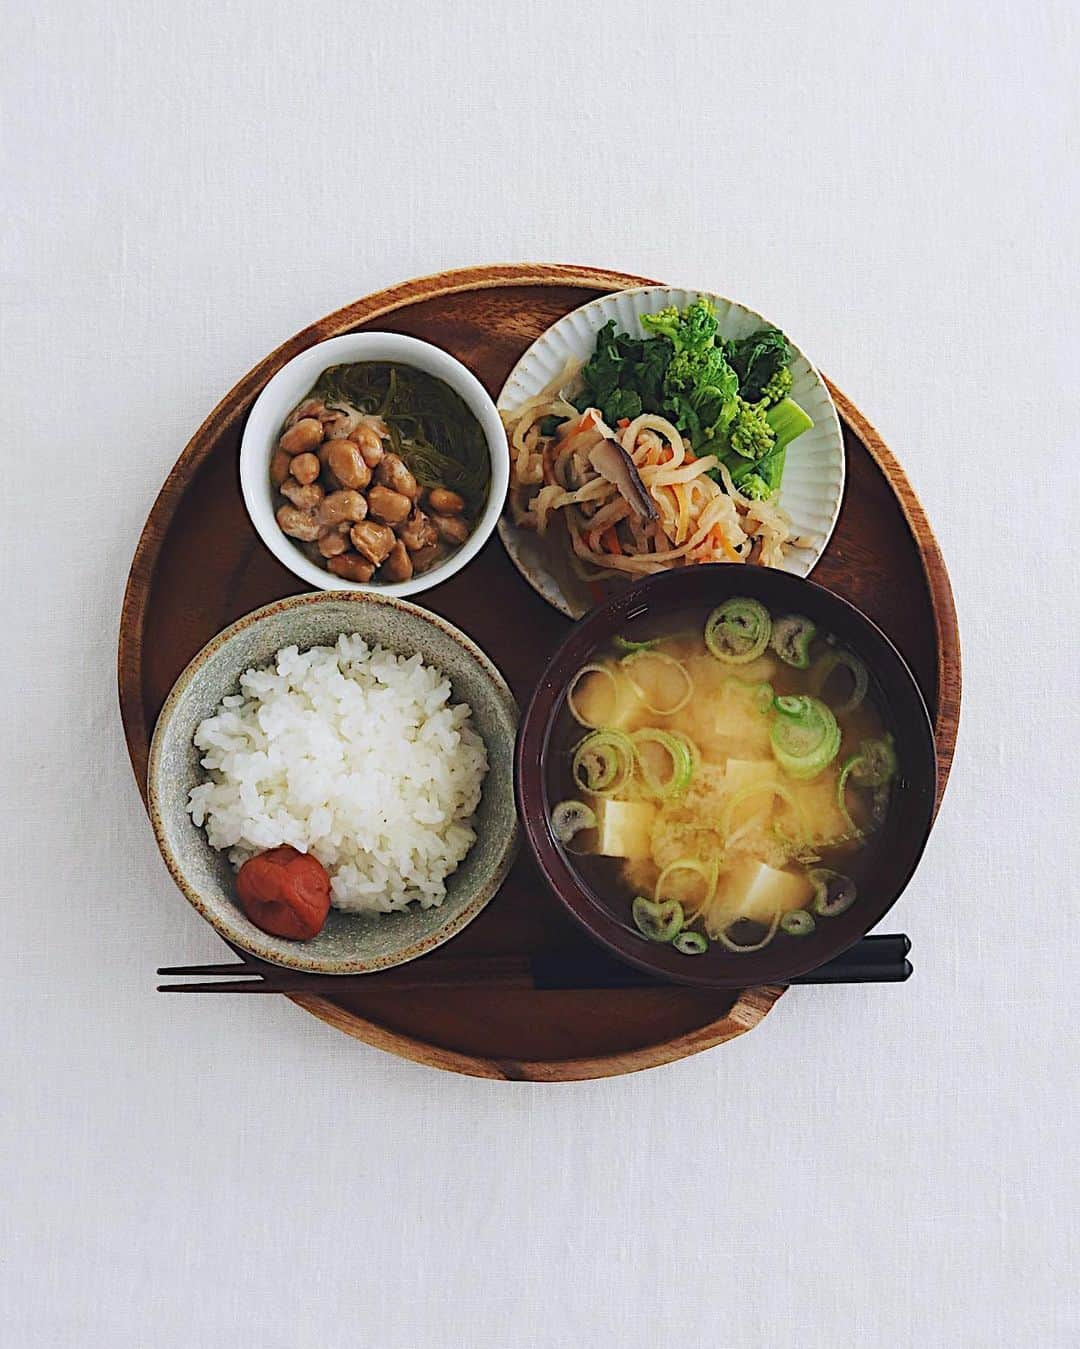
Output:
left=0, top=0, right=1080, bottom=1349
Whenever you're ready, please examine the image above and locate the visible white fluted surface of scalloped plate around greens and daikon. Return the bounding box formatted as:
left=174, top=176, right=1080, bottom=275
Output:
left=498, top=286, right=844, bottom=618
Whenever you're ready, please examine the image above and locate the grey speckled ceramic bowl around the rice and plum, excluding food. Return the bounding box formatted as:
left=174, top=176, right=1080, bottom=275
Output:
left=148, top=594, right=518, bottom=974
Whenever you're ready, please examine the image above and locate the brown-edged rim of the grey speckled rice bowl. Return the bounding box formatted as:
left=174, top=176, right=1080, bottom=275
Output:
left=147, top=591, right=520, bottom=975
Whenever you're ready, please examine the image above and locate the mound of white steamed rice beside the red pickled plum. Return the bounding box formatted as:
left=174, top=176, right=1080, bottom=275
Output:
left=187, top=634, right=488, bottom=913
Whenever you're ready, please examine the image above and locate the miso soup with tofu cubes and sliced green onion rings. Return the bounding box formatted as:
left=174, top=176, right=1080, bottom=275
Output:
left=551, top=596, right=898, bottom=956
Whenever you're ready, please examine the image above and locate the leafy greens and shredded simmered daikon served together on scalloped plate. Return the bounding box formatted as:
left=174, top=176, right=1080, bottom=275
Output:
left=502, top=297, right=813, bottom=581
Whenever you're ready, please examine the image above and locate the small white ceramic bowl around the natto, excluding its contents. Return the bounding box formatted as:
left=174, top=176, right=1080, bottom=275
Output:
left=240, top=333, right=510, bottom=596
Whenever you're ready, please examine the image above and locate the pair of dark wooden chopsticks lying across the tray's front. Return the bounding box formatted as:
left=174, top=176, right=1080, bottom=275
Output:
left=158, top=934, right=911, bottom=997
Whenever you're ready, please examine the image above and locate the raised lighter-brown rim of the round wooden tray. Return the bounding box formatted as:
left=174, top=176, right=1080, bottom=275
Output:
left=117, top=263, right=961, bottom=1082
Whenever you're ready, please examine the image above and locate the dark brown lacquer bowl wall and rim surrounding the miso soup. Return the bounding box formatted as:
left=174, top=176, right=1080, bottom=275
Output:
left=514, top=563, right=937, bottom=989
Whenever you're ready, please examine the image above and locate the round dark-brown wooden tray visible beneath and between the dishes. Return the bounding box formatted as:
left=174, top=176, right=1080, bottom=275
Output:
left=119, top=266, right=960, bottom=1082
